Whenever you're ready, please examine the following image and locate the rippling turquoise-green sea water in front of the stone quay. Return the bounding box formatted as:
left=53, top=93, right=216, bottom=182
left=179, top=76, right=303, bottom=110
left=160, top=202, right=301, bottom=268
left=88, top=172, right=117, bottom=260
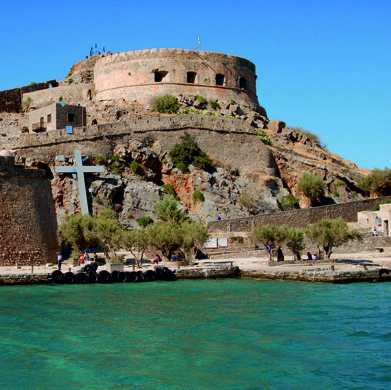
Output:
left=0, top=280, right=391, bottom=390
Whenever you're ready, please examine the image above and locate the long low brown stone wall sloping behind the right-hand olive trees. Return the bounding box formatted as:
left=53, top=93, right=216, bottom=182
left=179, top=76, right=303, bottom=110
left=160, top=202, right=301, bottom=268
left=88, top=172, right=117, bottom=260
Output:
left=208, top=196, right=391, bottom=233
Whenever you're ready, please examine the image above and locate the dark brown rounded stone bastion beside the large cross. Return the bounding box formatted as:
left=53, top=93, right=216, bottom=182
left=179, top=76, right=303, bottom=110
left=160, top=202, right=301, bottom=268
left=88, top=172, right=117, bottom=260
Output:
left=0, top=157, right=57, bottom=266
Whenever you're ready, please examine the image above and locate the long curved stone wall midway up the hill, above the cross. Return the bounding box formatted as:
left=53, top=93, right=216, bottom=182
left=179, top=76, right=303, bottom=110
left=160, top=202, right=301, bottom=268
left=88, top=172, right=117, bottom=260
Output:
left=0, top=115, right=278, bottom=176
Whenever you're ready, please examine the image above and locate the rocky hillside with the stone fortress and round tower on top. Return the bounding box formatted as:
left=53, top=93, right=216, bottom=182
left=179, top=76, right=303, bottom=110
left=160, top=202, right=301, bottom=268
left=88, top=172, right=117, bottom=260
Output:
left=0, top=49, right=376, bottom=266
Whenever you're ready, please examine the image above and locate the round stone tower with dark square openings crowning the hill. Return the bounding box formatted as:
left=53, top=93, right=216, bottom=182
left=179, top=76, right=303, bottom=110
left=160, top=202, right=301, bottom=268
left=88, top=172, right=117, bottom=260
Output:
left=94, top=49, right=259, bottom=106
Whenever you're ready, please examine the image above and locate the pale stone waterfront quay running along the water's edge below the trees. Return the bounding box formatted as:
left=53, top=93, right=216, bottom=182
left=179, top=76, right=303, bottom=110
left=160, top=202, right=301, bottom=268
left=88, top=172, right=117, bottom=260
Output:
left=0, top=248, right=391, bottom=284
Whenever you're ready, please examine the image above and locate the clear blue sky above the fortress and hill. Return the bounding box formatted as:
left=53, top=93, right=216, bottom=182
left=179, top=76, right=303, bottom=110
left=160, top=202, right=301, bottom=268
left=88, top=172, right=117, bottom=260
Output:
left=0, top=0, right=391, bottom=169
